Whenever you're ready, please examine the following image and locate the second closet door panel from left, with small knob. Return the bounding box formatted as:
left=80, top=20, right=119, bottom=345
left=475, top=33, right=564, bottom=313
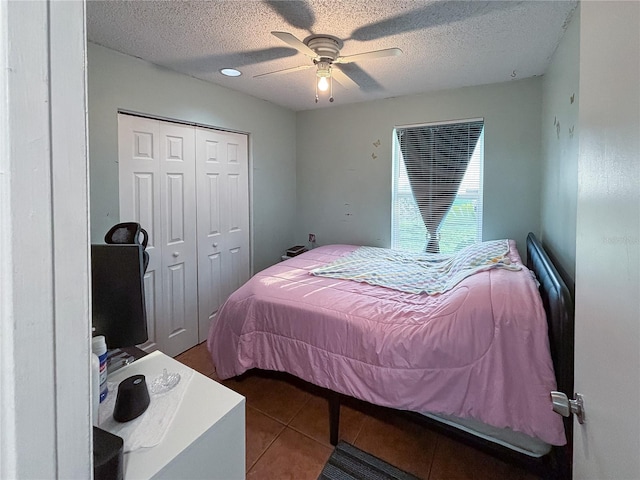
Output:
left=158, top=122, right=198, bottom=356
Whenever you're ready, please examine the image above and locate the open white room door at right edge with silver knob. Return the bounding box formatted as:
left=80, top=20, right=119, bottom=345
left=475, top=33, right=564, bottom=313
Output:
left=574, top=1, right=640, bottom=479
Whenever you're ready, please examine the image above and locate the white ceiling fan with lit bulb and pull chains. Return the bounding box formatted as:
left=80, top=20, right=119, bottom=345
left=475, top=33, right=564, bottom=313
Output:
left=254, top=32, right=402, bottom=103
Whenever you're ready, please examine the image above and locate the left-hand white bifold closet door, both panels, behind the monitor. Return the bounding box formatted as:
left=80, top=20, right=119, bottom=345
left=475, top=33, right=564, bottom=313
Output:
left=118, top=114, right=198, bottom=356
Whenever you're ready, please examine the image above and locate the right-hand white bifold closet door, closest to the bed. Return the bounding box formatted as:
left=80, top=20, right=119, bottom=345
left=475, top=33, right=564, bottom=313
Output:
left=196, top=128, right=250, bottom=341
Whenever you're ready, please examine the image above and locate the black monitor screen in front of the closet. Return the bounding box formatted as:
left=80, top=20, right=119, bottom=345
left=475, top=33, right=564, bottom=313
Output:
left=91, top=244, right=148, bottom=350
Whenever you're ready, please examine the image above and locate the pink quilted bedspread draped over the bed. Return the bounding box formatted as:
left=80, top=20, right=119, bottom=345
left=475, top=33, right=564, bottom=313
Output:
left=208, top=241, right=566, bottom=445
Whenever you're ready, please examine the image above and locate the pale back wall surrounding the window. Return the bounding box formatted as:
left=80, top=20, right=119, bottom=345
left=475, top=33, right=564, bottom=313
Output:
left=296, top=78, right=542, bottom=253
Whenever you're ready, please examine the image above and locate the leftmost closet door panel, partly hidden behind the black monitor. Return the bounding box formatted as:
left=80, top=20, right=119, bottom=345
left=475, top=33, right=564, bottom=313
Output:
left=119, top=115, right=165, bottom=352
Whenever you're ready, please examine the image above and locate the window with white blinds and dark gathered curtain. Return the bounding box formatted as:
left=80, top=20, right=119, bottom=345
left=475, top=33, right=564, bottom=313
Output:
left=391, top=120, right=484, bottom=253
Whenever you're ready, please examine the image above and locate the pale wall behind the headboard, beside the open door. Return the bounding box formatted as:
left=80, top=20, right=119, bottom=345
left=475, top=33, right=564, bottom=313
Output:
left=540, top=9, right=580, bottom=279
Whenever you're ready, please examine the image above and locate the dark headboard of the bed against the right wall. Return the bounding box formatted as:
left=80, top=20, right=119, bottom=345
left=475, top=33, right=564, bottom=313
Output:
left=527, top=233, right=574, bottom=478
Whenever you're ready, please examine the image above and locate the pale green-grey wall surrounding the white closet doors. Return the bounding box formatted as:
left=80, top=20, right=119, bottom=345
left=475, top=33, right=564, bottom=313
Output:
left=88, top=44, right=296, bottom=271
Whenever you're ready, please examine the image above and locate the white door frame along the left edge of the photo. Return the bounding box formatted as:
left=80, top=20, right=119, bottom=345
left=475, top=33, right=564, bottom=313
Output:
left=0, top=1, right=93, bottom=478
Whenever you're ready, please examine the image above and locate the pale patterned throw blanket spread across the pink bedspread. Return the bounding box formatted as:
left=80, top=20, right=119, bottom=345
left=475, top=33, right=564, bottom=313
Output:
left=310, top=240, right=521, bottom=295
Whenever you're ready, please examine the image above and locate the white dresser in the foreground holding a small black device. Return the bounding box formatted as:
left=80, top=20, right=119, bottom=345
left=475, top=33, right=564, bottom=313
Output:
left=102, top=352, right=245, bottom=480
